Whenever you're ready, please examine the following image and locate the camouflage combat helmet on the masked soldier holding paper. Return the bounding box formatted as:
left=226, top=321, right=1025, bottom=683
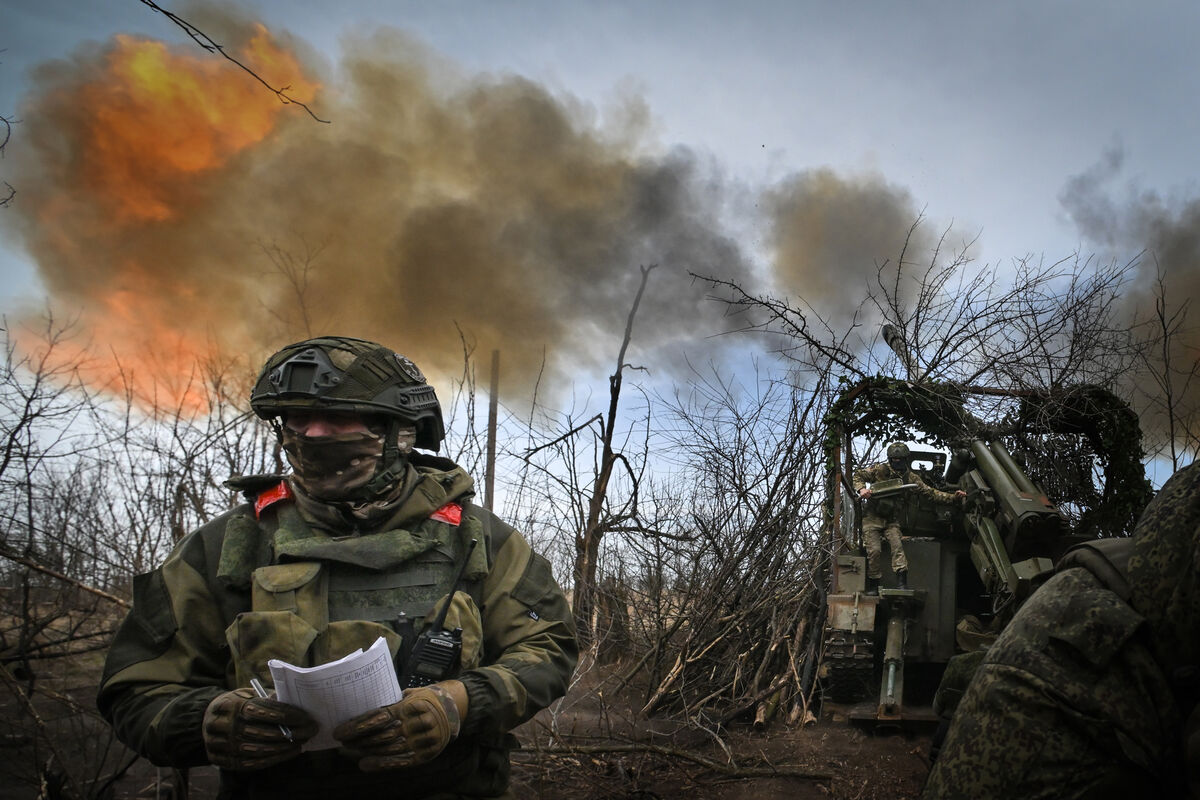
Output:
left=250, top=336, right=445, bottom=451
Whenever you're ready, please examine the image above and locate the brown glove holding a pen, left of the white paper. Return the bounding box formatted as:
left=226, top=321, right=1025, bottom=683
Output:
left=202, top=688, right=317, bottom=771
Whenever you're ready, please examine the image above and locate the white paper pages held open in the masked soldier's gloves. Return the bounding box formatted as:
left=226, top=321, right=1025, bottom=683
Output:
left=266, top=636, right=401, bottom=750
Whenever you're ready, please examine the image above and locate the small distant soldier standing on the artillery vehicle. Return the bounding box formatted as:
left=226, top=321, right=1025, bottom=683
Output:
left=854, top=441, right=967, bottom=595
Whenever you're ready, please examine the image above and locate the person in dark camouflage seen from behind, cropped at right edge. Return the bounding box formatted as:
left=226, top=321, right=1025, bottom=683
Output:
left=924, top=463, right=1200, bottom=800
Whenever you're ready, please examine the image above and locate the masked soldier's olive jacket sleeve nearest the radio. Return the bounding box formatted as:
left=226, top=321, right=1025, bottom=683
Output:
left=460, top=533, right=578, bottom=733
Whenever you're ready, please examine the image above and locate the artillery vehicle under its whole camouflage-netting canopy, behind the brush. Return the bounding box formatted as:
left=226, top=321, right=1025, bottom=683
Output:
left=820, top=378, right=1150, bottom=727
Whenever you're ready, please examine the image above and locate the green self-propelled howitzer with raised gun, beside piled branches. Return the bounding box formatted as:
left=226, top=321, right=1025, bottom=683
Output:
left=820, top=378, right=1144, bottom=724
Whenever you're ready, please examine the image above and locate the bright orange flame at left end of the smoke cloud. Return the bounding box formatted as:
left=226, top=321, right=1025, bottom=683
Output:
left=23, top=25, right=319, bottom=413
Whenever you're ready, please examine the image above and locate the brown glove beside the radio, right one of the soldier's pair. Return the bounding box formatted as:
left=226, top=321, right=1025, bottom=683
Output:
left=334, top=680, right=467, bottom=772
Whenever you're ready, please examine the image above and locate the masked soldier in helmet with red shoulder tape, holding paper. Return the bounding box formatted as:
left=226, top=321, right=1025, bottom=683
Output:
left=98, top=337, right=577, bottom=799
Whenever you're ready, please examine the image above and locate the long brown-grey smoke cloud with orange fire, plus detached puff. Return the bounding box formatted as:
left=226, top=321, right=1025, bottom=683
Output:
left=2, top=5, right=936, bottom=405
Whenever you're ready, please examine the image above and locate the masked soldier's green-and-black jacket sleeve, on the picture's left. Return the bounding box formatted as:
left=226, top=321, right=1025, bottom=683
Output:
left=96, top=522, right=228, bottom=768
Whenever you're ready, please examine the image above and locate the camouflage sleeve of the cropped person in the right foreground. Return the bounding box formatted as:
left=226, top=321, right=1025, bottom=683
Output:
left=923, top=570, right=1174, bottom=800
